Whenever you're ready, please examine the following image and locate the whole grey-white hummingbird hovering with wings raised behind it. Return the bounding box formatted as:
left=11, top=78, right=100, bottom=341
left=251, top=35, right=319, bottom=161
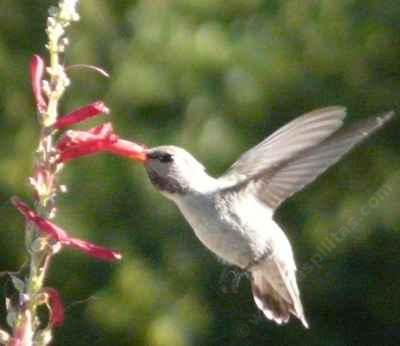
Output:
left=129, top=106, right=394, bottom=328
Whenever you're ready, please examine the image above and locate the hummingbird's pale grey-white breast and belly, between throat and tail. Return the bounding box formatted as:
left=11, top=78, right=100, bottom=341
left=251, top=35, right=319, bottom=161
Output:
left=174, top=189, right=280, bottom=268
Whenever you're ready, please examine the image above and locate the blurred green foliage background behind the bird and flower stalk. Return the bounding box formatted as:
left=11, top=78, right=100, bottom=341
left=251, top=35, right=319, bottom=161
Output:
left=0, top=0, right=400, bottom=346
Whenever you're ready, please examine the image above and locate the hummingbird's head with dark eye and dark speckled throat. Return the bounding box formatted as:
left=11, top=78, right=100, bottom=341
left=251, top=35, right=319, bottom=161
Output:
left=143, top=146, right=205, bottom=198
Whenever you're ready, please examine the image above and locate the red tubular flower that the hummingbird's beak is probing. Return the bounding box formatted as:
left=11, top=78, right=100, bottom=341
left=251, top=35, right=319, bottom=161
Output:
left=57, top=123, right=146, bottom=162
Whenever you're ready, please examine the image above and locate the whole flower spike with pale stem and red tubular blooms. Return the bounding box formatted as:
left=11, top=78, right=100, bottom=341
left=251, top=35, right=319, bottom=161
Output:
left=0, top=0, right=147, bottom=346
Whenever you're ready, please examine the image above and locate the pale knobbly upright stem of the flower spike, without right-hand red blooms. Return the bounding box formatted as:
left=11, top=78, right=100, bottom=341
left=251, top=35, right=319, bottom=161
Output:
left=4, top=0, right=79, bottom=346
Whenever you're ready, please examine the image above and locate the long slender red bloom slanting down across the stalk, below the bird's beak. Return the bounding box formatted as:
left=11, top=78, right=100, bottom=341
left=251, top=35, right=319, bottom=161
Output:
left=11, top=197, right=122, bottom=261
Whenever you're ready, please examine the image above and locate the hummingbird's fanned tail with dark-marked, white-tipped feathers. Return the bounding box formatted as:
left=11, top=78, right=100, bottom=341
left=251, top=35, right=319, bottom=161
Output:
left=250, top=257, right=308, bottom=328
